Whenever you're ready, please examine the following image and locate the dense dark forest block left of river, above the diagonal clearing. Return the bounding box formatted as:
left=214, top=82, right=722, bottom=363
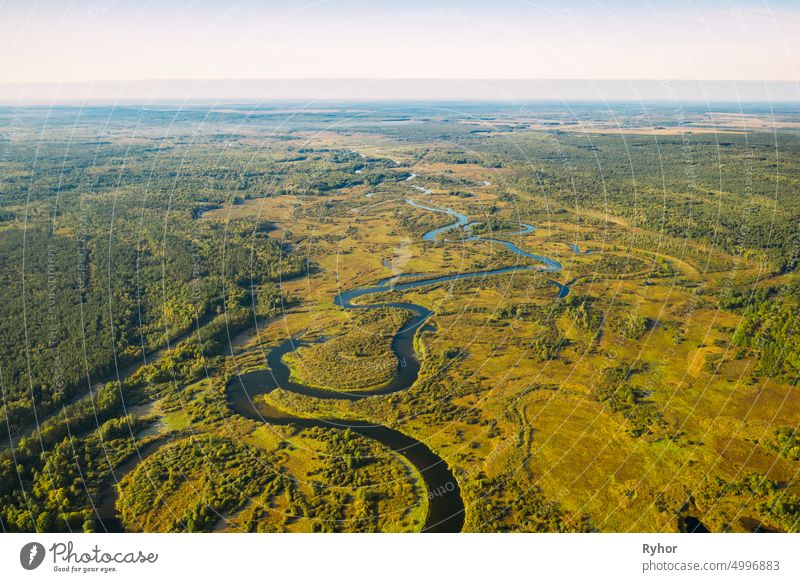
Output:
left=0, top=203, right=306, bottom=444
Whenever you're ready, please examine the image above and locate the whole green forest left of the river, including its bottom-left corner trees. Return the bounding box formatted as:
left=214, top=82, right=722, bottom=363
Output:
left=0, top=116, right=307, bottom=531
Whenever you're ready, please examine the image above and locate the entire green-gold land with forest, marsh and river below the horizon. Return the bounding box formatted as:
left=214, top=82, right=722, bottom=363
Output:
left=0, top=103, right=800, bottom=532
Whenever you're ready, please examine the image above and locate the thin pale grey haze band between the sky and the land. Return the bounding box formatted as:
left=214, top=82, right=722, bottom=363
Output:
left=0, top=78, right=800, bottom=105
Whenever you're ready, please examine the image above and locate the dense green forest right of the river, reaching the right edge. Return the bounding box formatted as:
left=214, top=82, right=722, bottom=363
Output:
left=462, top=131, right=800, bottom=269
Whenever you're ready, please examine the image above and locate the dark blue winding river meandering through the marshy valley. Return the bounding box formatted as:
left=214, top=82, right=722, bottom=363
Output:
left=227, top=174, right=569, bottom=532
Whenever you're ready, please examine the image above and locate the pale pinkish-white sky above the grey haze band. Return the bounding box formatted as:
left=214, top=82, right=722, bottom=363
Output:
left=0, top=0, right=800, bottom=101
